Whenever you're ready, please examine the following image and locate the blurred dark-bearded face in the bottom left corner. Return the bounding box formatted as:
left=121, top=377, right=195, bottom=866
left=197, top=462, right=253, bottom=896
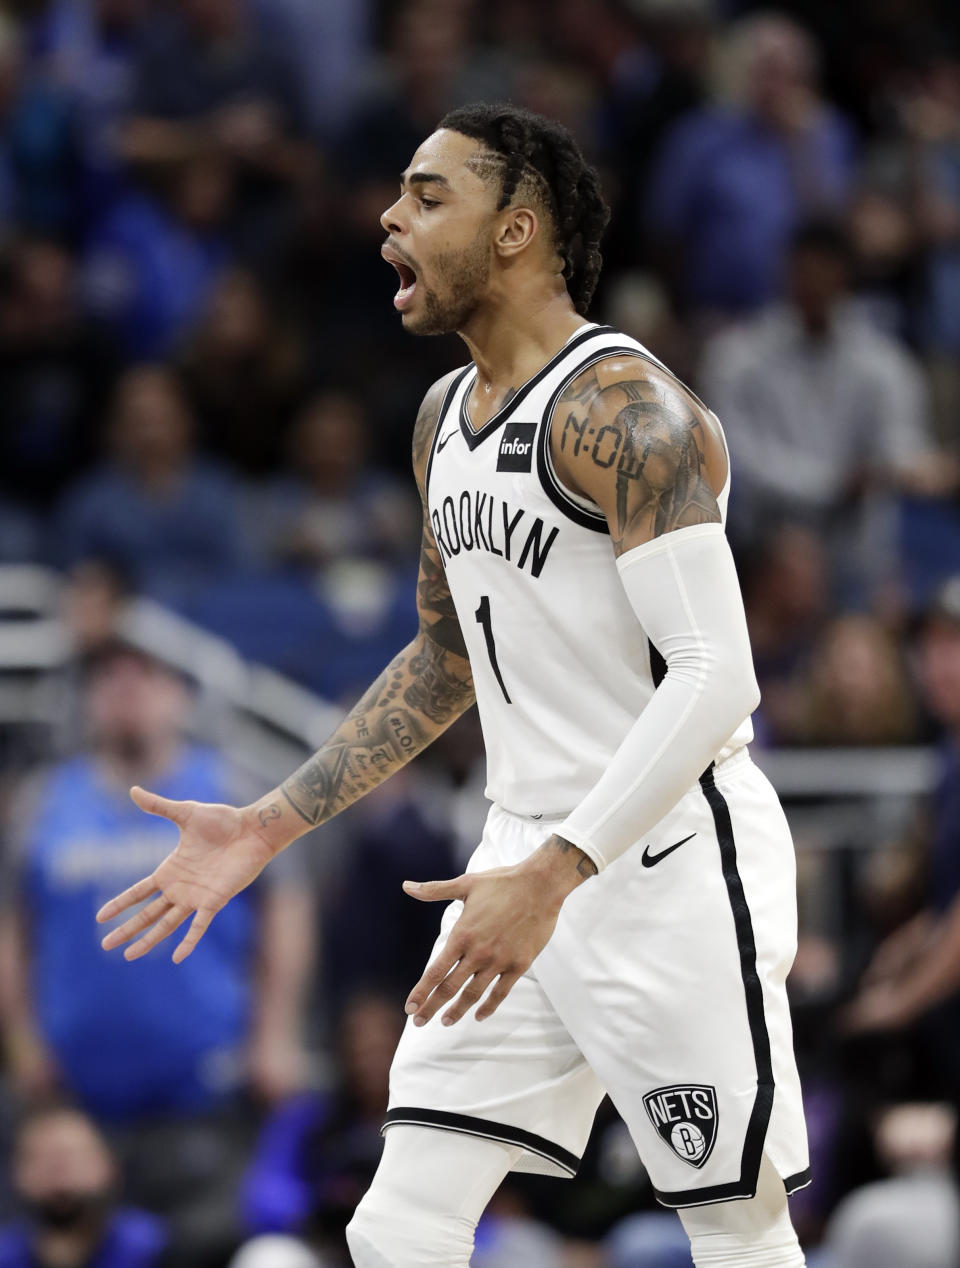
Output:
left=13, top=1110, right=117, bottom=1230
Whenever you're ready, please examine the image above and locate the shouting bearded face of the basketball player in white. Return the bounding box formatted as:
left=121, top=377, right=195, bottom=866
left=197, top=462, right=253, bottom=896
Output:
left=380, top=128, right=550, bottom=335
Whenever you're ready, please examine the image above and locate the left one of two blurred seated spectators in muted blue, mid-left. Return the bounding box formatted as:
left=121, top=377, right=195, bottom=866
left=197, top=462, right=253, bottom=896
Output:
left=53, top=366, right=245, bottom=604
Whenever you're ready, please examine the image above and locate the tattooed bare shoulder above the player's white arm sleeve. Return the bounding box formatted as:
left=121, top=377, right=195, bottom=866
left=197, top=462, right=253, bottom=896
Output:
left=558, top=368, right=720, bottom=554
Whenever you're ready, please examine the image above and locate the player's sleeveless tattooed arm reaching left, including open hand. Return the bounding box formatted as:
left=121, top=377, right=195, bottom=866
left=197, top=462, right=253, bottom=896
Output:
left=98, top=378, right=474, bottom=961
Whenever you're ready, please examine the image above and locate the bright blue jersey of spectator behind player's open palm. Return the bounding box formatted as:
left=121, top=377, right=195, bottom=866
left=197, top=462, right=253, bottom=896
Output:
left=20, top=748, right=256, bottom=1120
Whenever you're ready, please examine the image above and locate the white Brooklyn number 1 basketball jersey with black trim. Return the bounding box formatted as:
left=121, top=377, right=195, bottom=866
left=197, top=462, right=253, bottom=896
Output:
left=426, top=325, right=753, bottom=815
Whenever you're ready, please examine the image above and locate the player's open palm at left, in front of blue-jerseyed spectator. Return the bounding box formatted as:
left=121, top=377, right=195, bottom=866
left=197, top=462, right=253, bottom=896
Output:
left=96, top=787, right=275, bottom=964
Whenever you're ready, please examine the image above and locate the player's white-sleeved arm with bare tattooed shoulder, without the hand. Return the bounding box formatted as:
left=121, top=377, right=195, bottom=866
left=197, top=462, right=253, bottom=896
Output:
left=550, top=358, right=760, bottom=869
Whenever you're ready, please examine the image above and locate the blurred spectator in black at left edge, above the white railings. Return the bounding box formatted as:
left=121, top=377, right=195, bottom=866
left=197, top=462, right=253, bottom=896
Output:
left=0, top=237, right=115, bottom=506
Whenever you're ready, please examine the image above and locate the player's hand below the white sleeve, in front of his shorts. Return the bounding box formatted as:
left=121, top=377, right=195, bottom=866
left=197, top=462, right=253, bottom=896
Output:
left=403, top=853, right=582, bottom=1026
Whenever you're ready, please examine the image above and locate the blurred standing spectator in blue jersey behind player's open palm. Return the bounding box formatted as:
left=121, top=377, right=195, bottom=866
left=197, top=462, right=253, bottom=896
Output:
left=0, top=643, right=312, bottom=1264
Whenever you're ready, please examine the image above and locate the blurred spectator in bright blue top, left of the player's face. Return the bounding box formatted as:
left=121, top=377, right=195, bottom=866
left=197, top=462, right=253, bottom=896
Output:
left=82, top=152, right=235, bottom=361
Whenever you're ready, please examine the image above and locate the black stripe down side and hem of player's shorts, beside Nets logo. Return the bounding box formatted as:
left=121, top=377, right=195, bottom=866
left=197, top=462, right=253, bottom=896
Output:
left=653, top=762, right=781, bottom=1207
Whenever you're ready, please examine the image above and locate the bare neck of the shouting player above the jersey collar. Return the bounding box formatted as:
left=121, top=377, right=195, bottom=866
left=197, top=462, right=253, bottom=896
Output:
left=459, top=289, right=585, bottom=399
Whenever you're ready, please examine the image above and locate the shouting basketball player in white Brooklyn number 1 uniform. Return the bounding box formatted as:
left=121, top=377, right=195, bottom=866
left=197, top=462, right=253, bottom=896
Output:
left=100, top=105, right=809, bottom=1268
